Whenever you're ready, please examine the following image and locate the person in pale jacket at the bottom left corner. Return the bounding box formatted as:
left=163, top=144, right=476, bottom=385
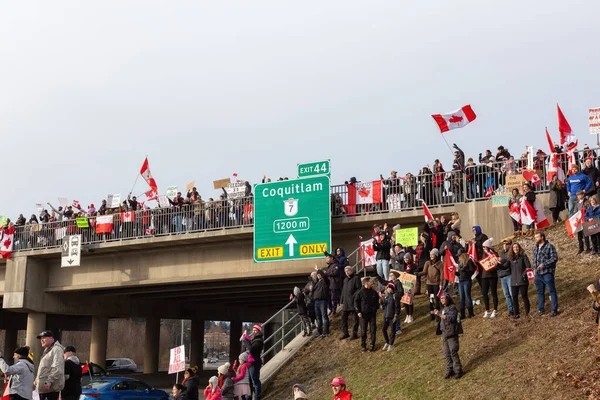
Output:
left=0, top=347, right=33, bottom=400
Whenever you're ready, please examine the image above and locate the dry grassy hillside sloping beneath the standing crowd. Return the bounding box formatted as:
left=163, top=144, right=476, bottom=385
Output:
left=264, top=225, right=600, bottom=400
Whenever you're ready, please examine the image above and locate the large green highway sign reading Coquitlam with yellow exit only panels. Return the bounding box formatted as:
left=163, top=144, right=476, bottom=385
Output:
left=254, top=177, right=331, bottom=262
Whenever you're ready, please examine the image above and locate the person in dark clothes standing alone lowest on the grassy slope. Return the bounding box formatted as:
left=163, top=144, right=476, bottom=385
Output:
left=435, top=292, right=463, bottom=379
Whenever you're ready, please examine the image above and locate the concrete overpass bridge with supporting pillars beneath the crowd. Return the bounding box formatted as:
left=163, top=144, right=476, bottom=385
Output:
left=0, top=195, right=547, bottom=373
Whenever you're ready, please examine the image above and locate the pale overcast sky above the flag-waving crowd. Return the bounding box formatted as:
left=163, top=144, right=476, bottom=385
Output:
left=0, top=0, right=600, bottom=220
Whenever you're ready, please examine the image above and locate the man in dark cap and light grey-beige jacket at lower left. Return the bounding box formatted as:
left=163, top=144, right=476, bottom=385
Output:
left=35, top=330, right=65, bottom=400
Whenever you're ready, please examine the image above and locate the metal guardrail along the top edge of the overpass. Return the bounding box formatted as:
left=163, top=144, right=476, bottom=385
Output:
left=13, top=149, right=598, bottom=253
